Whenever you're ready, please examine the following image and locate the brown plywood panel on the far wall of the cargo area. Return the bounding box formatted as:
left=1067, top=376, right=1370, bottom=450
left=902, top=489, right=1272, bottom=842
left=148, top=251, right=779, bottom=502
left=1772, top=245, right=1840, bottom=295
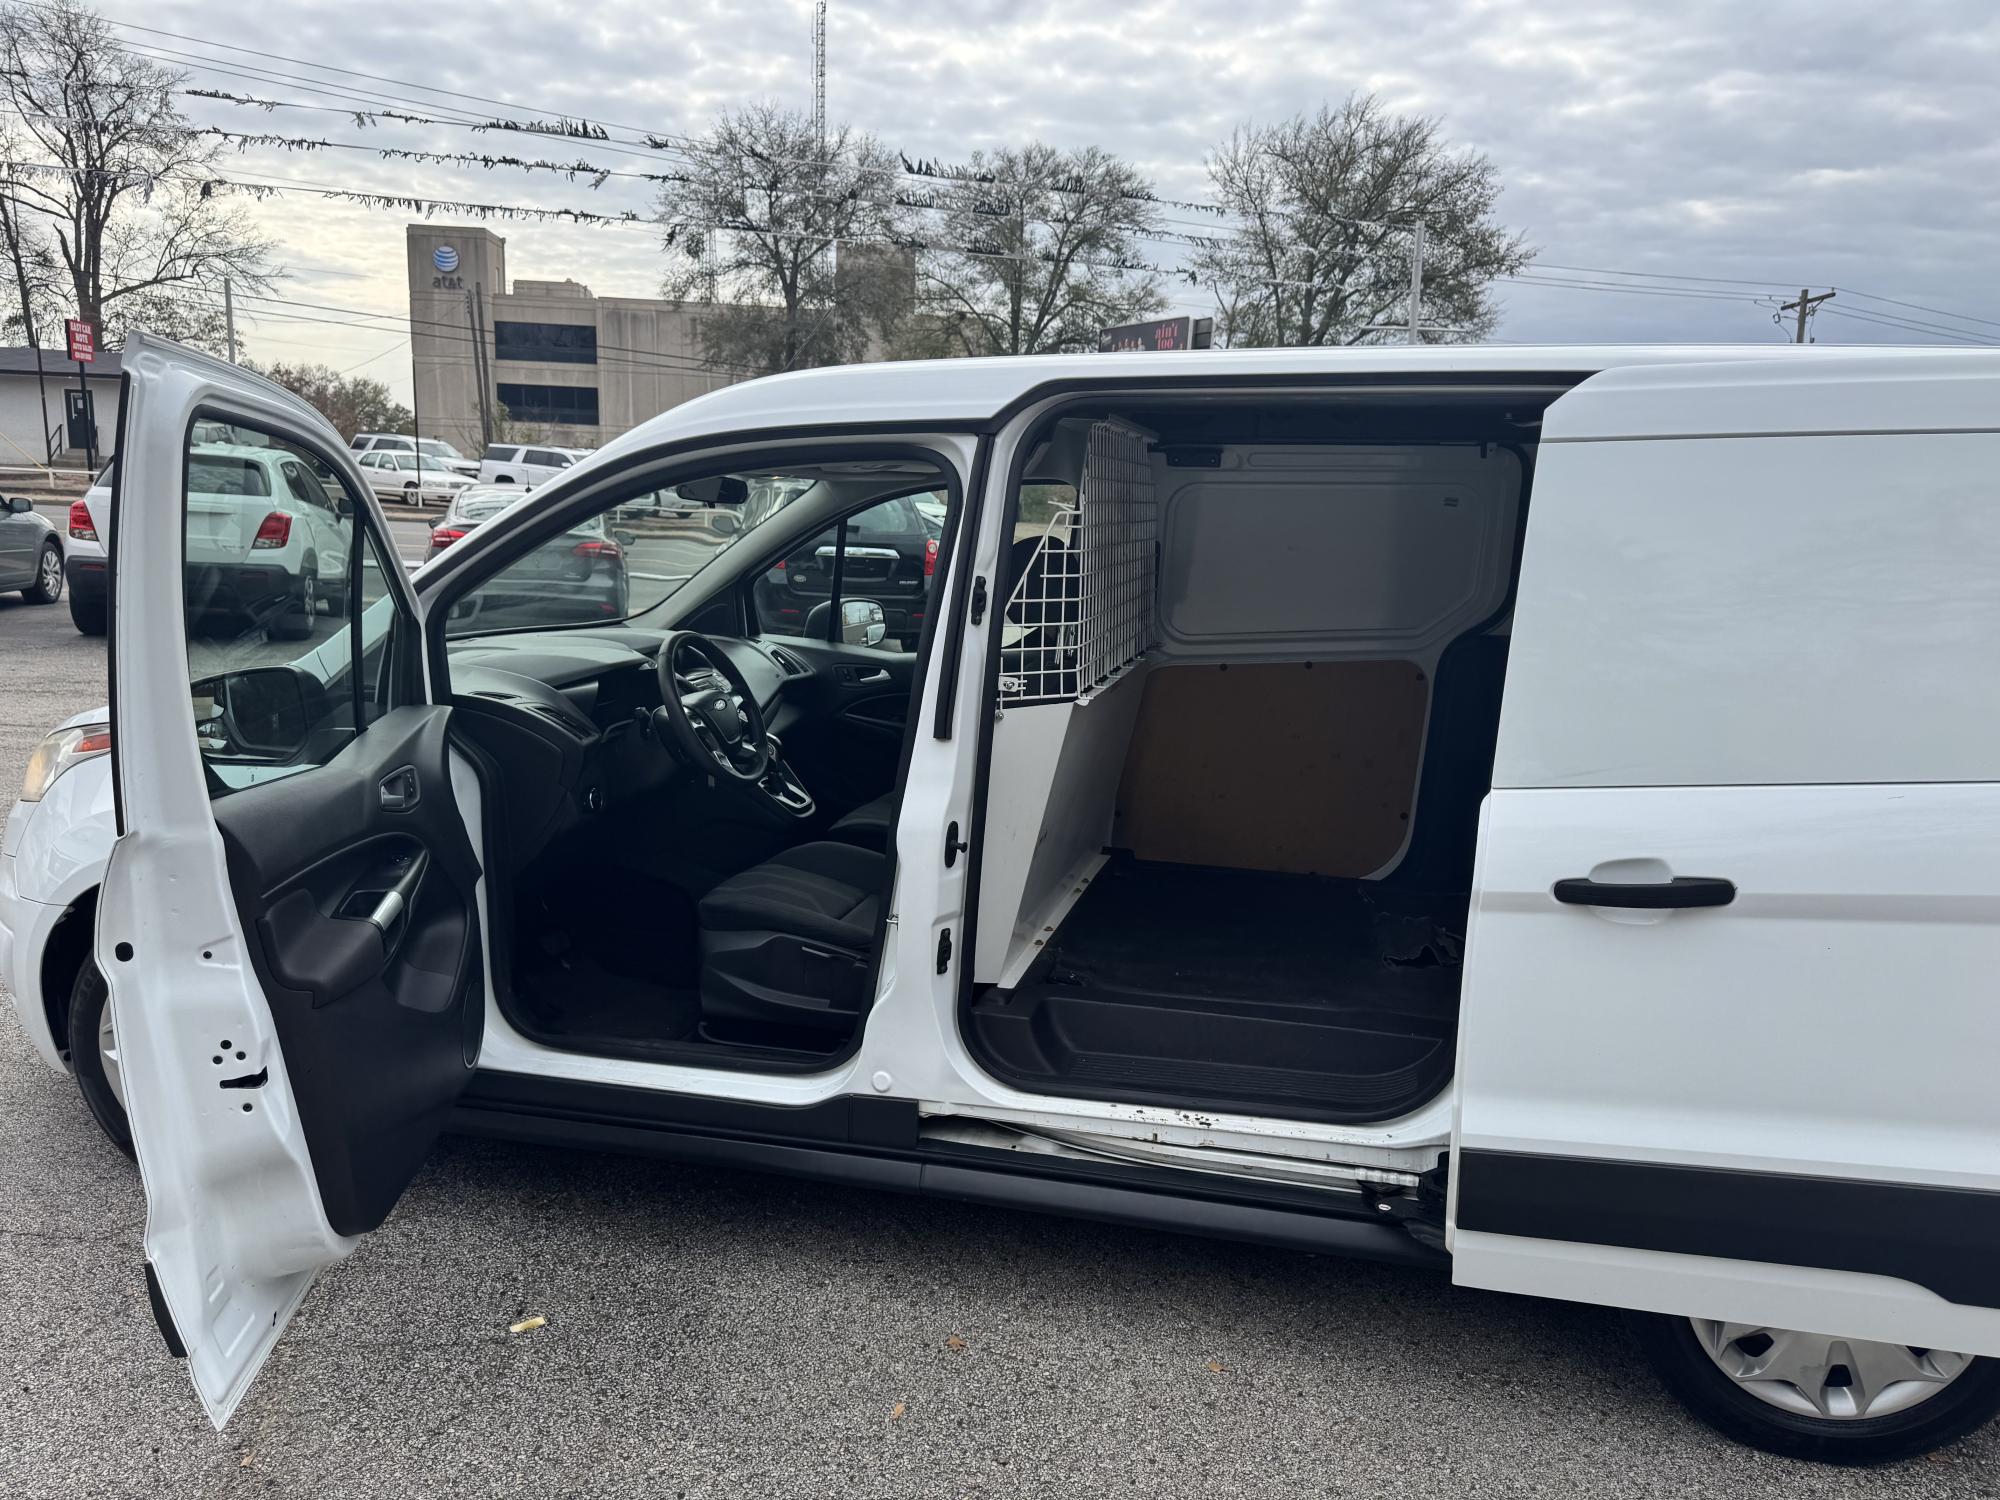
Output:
left=1114, top=662, right=1430, bottom=876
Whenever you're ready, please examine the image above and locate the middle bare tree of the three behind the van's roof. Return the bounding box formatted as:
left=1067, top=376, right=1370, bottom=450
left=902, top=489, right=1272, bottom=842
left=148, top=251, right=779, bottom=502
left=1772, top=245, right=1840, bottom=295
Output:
left=900, top=142, right=1166, bottom=354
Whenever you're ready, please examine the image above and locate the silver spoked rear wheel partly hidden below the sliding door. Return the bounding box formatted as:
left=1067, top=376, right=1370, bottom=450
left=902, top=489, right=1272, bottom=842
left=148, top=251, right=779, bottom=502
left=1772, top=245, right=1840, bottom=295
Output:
left=1690, top=1318, right=1972, bottom=1422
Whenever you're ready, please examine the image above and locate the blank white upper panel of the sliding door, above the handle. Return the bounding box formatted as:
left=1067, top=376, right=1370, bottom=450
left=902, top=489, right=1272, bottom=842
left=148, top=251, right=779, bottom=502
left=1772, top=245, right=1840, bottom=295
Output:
left=1494, top=428, right=2000, bottom=786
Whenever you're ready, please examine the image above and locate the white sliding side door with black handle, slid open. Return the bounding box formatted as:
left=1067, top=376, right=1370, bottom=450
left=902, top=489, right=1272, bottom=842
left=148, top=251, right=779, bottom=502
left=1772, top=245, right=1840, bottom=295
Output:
left=1450, top=350, right=2000, bottom=1354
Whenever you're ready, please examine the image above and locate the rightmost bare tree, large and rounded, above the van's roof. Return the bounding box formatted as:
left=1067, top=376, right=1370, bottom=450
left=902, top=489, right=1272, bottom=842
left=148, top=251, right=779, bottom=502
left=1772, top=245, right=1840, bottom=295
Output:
left=1194, top=94, right=1534, bottom=348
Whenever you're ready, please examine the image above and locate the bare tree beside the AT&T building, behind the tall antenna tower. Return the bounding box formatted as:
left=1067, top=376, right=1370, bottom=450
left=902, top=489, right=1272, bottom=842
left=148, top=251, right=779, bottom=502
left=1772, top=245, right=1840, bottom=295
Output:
left=658, top=104, right=910, bottom=372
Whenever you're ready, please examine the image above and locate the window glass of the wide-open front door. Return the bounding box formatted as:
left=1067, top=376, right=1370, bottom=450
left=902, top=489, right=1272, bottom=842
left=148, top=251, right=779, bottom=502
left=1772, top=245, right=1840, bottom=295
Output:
left=182, top=422, right=400, bottom=796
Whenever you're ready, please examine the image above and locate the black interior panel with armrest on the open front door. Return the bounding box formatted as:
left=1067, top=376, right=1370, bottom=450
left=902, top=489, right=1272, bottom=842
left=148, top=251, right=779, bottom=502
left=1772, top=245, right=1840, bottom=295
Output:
left=214, top=704, right=486, bottom=1234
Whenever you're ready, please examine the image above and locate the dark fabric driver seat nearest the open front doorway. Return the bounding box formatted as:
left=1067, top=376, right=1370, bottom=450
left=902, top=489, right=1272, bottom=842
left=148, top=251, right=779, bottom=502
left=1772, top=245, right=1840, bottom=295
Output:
left=696, top=844, right=888, bottom=1042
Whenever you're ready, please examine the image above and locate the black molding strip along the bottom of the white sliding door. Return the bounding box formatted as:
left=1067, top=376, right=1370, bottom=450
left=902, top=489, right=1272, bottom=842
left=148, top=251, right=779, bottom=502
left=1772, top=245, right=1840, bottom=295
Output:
left=1458, top=1150, right=2000, bottom=1308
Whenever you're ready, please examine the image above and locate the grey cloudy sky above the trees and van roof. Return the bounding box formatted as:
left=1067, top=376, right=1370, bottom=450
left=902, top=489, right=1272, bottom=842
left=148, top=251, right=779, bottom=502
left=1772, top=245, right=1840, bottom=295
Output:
left=104, top=0, right=2000, bottom=392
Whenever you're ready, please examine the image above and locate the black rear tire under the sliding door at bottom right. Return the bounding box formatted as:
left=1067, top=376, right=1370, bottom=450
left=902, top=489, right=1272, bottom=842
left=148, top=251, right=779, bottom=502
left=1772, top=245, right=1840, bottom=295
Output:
left=1626, top=1312, right=2000, bottom=1466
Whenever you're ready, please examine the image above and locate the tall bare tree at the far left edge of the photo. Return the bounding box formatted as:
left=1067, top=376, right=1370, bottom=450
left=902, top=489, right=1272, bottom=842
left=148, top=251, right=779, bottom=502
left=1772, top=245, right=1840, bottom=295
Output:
left=0, top=0, right=274, bottom=348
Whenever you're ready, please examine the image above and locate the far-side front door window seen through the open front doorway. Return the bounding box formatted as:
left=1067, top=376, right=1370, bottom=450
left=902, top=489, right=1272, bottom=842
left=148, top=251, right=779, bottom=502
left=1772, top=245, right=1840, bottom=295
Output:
left=754, top=490, right=946, bottom=652
